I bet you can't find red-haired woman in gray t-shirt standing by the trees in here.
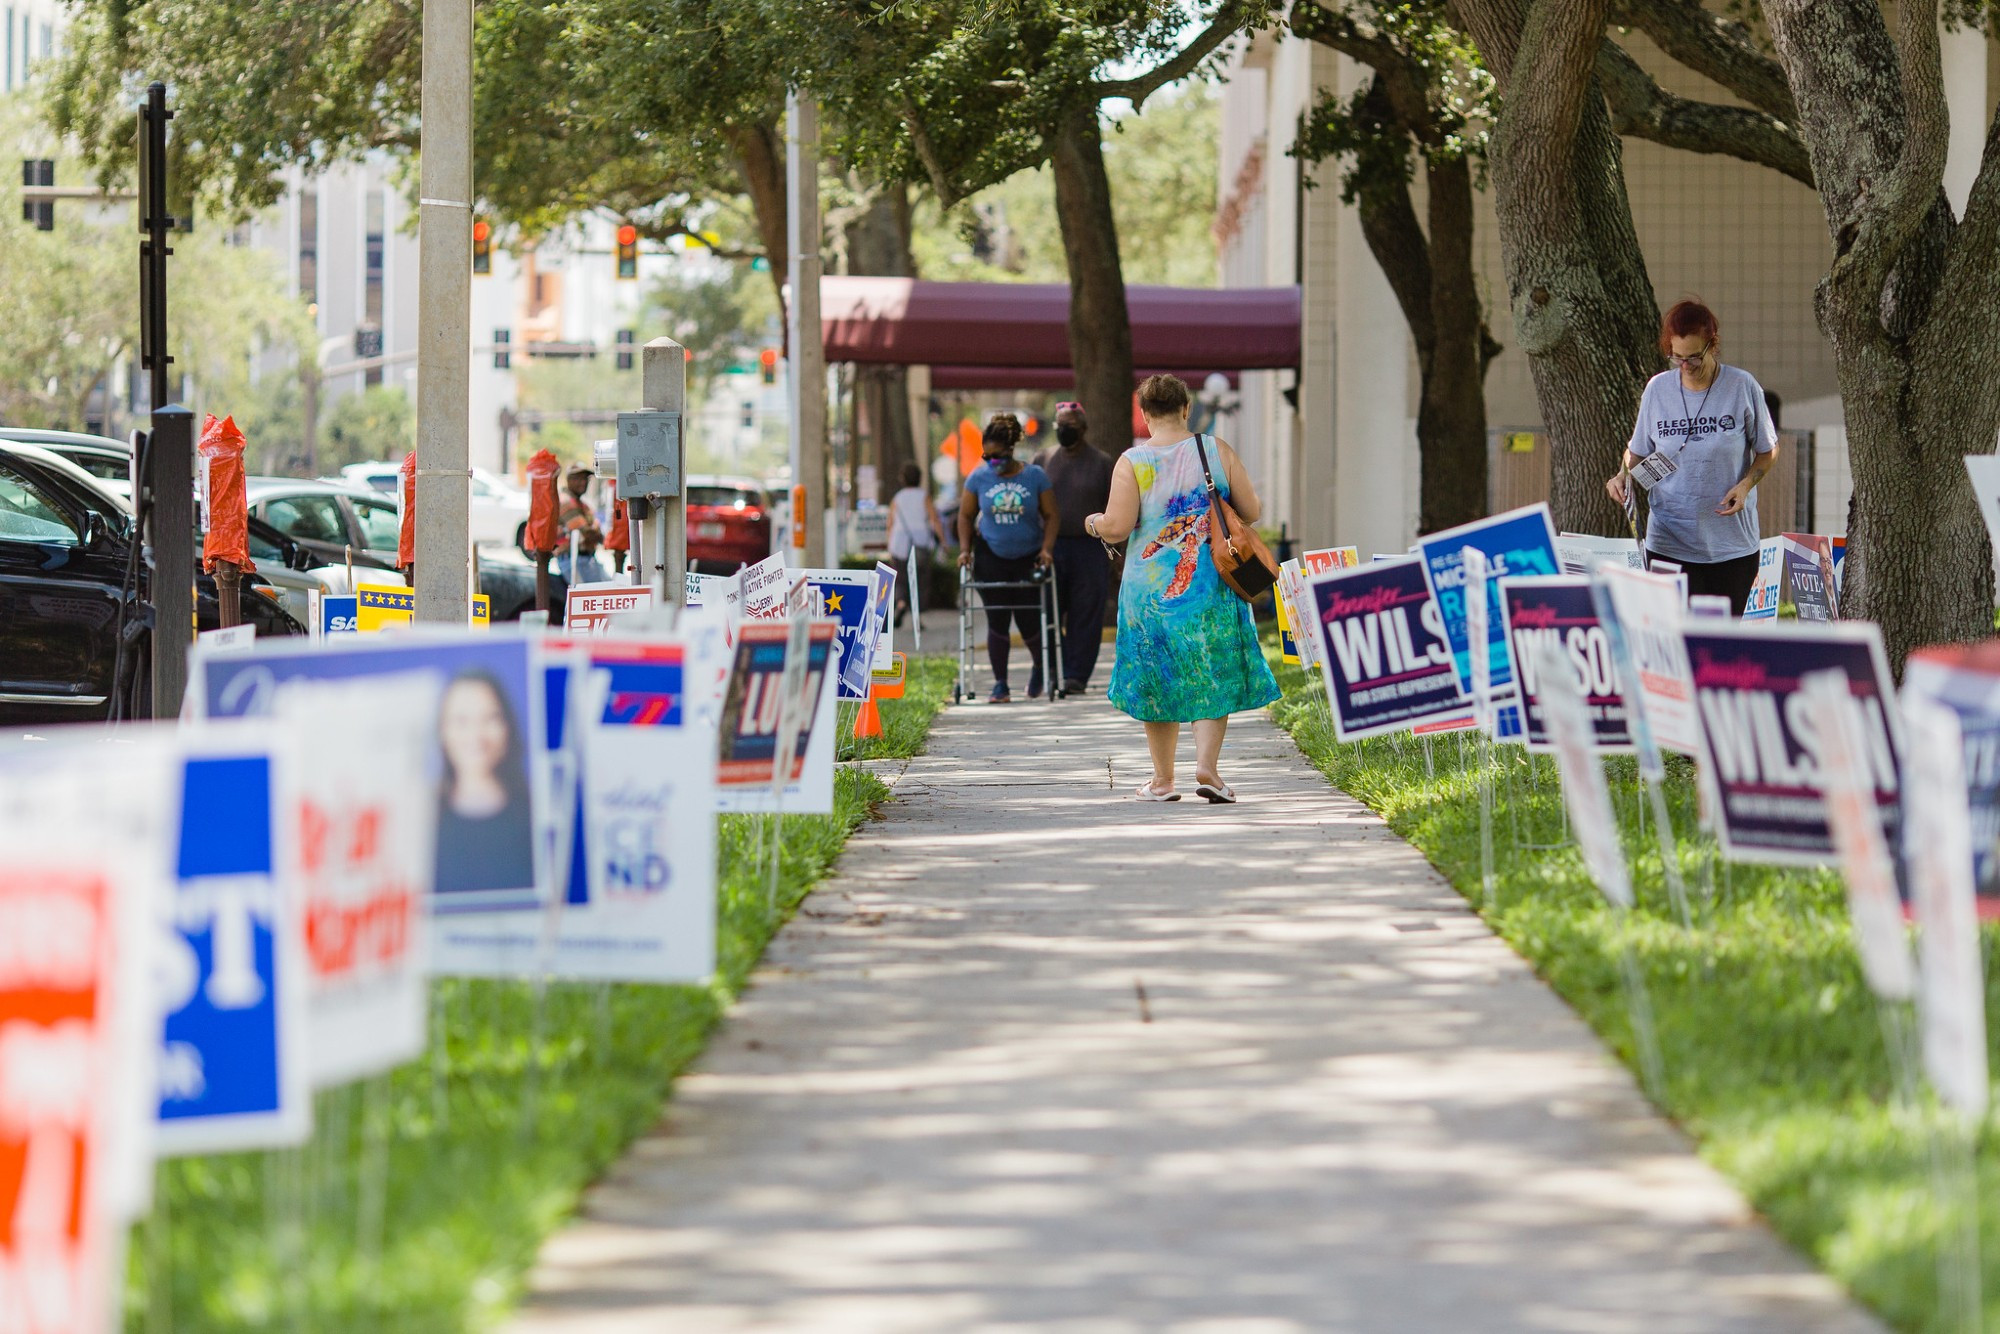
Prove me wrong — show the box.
[1604,302,1778,616]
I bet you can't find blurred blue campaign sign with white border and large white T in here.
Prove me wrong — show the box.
[156,730,312,1156]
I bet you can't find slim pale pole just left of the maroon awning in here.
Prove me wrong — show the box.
[784,90,820,568]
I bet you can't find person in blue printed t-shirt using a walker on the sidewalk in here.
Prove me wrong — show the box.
[958,412,1056,704]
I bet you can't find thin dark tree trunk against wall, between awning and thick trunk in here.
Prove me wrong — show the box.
[1416,158,1490,532]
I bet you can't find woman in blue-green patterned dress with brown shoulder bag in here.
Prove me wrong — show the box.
[1084,376,1278,802]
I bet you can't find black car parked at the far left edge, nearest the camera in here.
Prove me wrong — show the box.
[0,438,306,724]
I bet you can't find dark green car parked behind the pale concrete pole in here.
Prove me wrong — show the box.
[248,478,568,620]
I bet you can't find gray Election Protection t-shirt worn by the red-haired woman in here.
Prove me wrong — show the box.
[1632,366,1778,564]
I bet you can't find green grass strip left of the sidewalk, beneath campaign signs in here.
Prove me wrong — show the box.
[126,660,952,1334]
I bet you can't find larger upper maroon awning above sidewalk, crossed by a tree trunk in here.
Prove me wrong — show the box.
[820,278,1300,374]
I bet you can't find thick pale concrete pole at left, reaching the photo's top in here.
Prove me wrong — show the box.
[416,0,472,626]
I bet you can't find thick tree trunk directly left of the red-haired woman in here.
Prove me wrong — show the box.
[1460,0,1660,534]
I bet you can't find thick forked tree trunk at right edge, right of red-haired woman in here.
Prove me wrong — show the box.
[1764,0,2000,672]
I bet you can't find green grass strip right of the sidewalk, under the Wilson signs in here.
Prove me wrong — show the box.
[1272,660,2000,1334]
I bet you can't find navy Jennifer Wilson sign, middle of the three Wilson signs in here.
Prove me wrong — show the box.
[1500,574,1632,750]
